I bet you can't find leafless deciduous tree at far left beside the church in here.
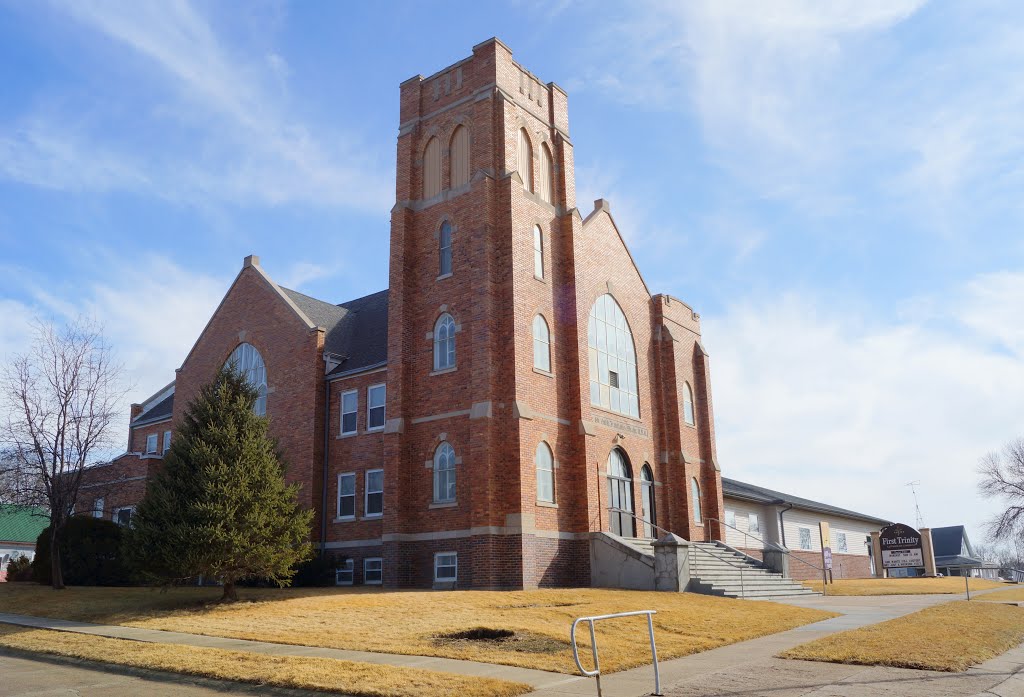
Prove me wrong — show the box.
[0,320,126,589]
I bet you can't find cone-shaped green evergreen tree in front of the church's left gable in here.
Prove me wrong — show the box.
[126,367,313,601]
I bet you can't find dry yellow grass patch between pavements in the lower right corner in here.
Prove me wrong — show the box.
[780,597,1024,671]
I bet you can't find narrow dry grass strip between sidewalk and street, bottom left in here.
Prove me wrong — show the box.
[0,624,530,697]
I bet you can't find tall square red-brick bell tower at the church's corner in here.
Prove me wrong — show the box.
[383,39,589,587]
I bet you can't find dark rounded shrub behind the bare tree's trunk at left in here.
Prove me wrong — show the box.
[32,516,129,585]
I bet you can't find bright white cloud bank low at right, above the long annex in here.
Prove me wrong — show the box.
[703,272,1024,540]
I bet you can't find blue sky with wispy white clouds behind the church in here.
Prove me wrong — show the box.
[0,0,1024,539]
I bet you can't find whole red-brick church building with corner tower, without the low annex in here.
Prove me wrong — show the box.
[79,39,724,589]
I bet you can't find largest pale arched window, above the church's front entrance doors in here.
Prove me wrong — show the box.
[587,294,640,419]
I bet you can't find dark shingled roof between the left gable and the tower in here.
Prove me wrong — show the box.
[281,288,388,375]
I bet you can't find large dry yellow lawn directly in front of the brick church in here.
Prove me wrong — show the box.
[0,583,834,673]
